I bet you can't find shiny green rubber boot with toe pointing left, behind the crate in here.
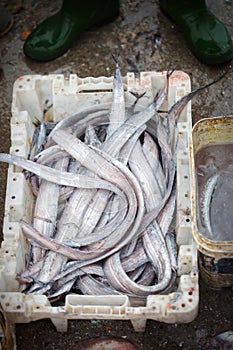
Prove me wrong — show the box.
[23,0,120,61]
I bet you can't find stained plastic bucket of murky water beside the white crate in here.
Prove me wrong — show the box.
[191,116,233,288]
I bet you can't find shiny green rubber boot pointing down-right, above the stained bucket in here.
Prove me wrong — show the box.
[160,0,233,65]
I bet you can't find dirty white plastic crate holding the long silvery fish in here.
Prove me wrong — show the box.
[0,71,199,332]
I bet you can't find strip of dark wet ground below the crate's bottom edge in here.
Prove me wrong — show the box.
[16,286,233,350]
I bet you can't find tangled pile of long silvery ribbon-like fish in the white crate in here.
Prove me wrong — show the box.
[0,61,226,301]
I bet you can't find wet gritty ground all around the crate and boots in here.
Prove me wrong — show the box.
[0,0,233,350]
